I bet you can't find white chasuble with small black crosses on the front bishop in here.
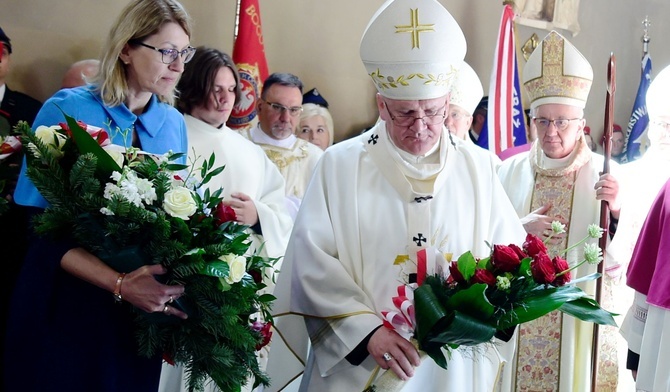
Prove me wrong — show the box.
[268,122,525,392]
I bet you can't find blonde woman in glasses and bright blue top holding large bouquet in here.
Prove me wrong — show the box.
[3,0,195,392]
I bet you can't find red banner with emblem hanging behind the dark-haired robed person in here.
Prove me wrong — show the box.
[228,0,268,128]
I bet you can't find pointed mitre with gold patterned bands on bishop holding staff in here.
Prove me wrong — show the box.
[523,31,593,109]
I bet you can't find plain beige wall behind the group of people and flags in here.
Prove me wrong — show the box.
[0,0,670,145]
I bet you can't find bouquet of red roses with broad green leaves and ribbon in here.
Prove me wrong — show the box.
[366,222,616,391]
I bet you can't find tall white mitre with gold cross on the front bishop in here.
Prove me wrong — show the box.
[360,0,466,100]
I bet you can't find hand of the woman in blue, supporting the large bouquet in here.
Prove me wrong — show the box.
[121,265,188,319]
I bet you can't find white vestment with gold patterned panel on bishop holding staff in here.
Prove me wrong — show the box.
[499,140,618,392]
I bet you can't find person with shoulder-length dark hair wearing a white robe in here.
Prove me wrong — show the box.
[159,47,293,392]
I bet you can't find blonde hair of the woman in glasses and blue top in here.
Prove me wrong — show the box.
[92,0,191,106]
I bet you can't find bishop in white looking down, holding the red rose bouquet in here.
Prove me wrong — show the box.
[268,0,525,392]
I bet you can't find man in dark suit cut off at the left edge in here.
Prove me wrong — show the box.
[0,28,42,384]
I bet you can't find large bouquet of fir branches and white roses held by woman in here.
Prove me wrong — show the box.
[19,116,276,391]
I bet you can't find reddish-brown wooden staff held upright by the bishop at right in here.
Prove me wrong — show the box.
[591,53,616,392]
